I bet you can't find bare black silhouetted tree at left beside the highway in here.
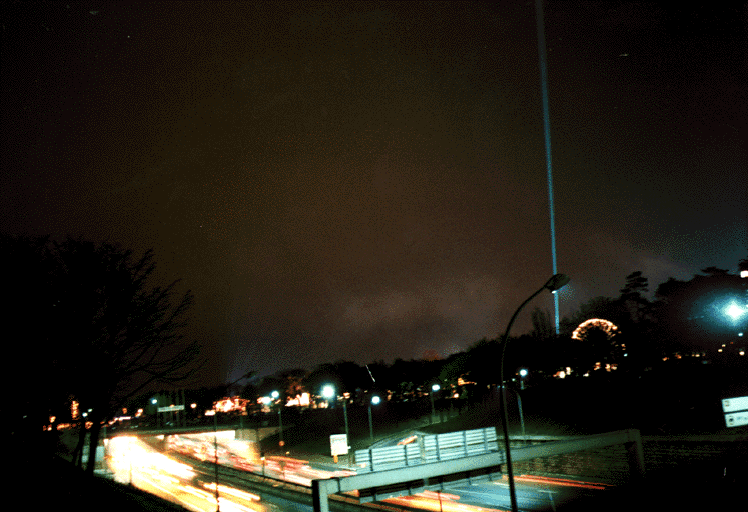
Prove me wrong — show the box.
[3,239,198,473]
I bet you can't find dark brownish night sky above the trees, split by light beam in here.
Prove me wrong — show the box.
[0,1,748,382]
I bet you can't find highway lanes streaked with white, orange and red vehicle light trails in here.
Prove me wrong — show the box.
[108,437,610,512]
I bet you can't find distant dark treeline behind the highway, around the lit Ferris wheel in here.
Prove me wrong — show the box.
[243,259,748,401]
